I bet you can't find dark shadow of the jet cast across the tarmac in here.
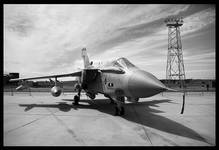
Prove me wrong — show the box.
[19,99,208,143]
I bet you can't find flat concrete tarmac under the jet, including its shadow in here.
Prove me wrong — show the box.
[3,92,216,146]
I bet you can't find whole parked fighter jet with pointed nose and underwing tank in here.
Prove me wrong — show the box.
[10,48,175,115]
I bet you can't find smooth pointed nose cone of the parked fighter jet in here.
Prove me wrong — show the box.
[128,70,166,97]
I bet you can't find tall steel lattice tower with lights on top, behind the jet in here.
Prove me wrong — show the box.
[164,16,186,89]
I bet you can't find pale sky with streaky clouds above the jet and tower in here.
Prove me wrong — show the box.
[3,4,216,79]
